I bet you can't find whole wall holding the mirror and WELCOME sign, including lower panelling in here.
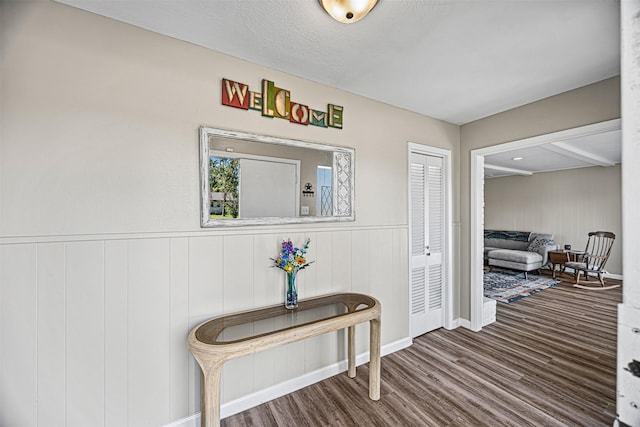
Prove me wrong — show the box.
[0,0,459,426]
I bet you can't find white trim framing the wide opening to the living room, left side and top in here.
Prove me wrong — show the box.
[469,119,621,331]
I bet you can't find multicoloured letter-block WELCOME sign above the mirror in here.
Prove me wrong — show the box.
[222,79,344,129]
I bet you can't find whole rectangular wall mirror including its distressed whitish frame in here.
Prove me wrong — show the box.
[200,127,355,227]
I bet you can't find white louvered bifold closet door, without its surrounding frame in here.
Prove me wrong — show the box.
[409,152,445,337]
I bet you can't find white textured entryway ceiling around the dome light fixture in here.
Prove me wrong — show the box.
[59,0,620,124]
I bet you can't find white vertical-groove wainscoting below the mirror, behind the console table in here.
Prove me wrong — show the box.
[0,227,409,427]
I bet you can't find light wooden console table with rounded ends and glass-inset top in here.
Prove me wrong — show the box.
[188,293,382,427]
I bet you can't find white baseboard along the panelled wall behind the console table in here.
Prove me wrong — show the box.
[163,337,413,427]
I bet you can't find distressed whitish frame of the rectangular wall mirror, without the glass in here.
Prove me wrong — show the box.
[200,126,355,228]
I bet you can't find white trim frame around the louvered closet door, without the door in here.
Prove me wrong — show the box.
[406,142,454,332]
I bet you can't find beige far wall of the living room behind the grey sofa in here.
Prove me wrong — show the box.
[484,165,623,276]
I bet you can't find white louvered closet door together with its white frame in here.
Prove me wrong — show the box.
[408,143,452,338]
